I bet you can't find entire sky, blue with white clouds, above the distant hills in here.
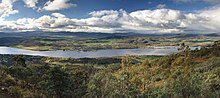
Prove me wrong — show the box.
[0,0,220,34]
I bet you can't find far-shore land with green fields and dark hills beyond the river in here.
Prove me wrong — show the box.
[0,32,220,51]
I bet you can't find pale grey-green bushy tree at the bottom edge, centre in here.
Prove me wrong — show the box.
[85,71,140,98]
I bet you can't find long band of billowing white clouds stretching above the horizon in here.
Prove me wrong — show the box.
[0,7,220,33]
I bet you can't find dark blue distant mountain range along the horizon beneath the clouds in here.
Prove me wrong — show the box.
[0,32,220,38]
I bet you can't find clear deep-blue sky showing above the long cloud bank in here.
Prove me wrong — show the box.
[7,0,215,20]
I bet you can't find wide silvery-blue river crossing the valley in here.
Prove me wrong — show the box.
[0,46,196,58]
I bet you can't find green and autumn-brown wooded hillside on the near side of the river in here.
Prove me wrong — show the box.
[0,42,220,98]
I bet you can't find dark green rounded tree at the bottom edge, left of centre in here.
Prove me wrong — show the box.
[40,66,72,98]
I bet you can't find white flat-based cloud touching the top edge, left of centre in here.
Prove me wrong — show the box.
[41,0,77,11]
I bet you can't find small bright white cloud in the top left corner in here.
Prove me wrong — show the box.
[0,0,18,18]
